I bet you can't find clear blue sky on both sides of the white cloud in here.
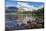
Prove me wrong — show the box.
[6,1,43,7]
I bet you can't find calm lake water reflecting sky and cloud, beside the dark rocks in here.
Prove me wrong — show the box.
[5,14,35,29]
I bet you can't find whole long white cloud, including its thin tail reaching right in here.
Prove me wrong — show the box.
[16,2,43,11]
